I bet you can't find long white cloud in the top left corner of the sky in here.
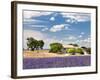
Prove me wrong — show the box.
[23,11,52,18]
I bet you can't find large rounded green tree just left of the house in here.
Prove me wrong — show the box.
[50,43,63,53]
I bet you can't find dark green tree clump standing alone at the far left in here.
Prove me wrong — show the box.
[27,37,44,51]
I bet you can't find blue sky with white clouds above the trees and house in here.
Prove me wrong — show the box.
[23,10,91,49]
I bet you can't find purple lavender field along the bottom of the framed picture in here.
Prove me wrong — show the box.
[23,56,91,69]
